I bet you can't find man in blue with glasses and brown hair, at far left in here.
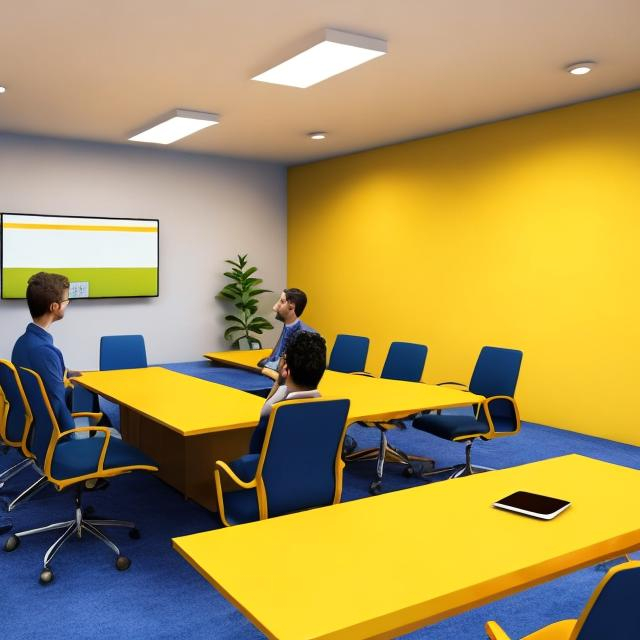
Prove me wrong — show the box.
[11,272,80,431]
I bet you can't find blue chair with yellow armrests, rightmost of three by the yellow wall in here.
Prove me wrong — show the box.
[413,347,522,478]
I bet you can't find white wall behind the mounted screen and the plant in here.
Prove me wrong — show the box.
[0,134,287,369]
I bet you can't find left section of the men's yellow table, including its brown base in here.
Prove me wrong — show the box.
[76,367,264,511]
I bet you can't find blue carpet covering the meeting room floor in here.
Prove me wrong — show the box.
[0,410,640,640]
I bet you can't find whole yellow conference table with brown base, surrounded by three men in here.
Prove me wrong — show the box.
[77,362,482,510]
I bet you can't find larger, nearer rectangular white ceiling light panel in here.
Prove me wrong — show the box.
[252,29,387,89]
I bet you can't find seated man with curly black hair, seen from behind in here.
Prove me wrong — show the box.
[229,331,327,482]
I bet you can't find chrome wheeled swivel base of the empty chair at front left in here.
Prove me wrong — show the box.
[4,488,140,585]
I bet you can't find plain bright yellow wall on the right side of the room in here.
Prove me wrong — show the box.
[288,92,640,445]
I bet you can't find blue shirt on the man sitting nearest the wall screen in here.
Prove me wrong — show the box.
[11,322,75,431]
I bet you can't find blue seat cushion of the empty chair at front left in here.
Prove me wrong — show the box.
[51,438,157,480]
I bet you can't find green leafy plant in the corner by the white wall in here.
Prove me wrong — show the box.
[218,254,273,349]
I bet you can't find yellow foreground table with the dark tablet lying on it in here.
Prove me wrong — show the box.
[173,455,640,640]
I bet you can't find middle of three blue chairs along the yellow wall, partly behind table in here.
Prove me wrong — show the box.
[345,342,434,495]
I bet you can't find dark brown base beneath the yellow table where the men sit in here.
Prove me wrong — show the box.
[120,406,253,511]
